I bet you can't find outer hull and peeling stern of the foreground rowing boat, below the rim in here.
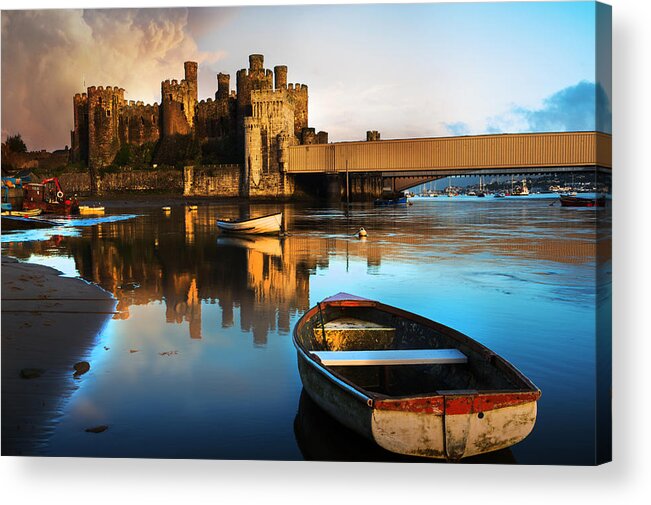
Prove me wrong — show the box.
[298,353,538,460]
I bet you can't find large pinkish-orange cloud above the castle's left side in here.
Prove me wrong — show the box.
[2,9,229,150]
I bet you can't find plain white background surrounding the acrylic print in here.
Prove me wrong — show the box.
[0,0,651,505]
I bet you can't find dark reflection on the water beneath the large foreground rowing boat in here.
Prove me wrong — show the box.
[294,390,517,464]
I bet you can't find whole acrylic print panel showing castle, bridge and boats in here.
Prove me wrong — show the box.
[2,2,612,465]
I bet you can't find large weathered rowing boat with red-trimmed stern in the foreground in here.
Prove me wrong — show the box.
[293,293,540,460]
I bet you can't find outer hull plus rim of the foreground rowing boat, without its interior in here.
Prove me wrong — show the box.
[294,292,540,460]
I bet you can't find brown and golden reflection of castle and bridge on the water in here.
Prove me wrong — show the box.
[3,201,610,345]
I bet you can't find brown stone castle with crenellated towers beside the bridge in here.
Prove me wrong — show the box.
[71,54,328,196]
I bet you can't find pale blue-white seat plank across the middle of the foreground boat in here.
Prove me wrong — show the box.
[312,349,468,366]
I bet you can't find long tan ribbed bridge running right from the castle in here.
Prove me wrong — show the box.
[285,132,612,191]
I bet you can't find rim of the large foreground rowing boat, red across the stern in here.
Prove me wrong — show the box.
[292,295,541,411]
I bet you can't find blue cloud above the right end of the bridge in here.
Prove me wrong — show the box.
[486,81,612,133]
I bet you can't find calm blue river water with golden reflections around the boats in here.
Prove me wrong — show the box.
[2,195,611,464]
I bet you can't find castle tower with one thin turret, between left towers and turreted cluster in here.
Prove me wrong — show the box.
[161,61,198,137]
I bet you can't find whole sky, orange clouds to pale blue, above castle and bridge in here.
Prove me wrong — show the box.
[2,2,611,150]
